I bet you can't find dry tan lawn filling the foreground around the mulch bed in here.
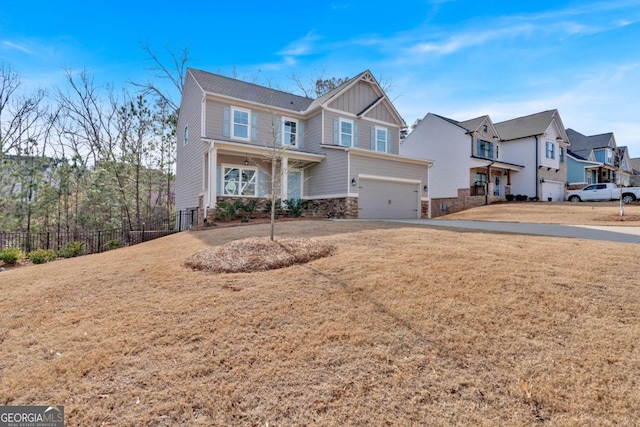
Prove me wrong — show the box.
[0,204,640,426]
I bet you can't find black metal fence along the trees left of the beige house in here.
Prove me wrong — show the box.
[0,209,198,255]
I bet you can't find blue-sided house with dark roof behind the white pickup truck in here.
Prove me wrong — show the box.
[567,129,632,188]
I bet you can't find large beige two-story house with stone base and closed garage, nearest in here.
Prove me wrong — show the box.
[176,68,432,222]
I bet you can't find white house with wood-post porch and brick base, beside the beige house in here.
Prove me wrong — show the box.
[400,113,524,216]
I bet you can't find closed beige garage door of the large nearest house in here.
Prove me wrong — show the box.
[358,179,420,219]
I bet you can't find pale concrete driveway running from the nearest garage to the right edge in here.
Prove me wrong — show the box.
[378,219,640,244]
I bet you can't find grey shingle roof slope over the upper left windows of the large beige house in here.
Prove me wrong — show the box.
[189,68,313,112]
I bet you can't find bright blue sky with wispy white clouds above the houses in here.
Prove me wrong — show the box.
[0,0,640,157]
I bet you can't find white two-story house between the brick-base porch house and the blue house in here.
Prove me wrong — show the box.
[495,109,570,201]
